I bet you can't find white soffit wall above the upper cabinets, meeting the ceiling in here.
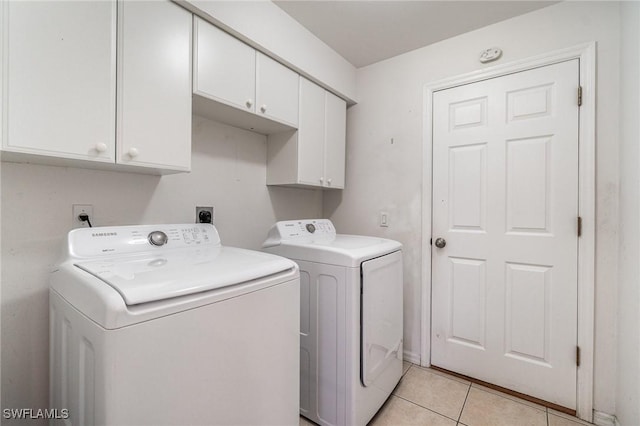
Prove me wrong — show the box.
[178,0,356,102]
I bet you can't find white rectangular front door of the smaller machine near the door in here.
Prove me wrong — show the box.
[360,251,403,386]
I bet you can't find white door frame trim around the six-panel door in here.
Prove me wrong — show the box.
[420,42,596,421]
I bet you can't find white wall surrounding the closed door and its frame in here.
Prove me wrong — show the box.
[323,2,620,413]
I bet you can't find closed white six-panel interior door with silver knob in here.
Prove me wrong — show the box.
[431,60,579,409]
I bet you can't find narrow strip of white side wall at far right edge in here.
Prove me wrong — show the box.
[616,2,640,426]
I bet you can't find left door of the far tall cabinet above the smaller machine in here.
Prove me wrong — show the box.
[298,77,325,186]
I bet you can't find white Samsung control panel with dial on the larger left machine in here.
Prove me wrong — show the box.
[68,223,220,258]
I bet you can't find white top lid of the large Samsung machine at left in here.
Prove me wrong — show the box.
[74,246,295,305]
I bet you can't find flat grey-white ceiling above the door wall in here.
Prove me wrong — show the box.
[274,0,558,68]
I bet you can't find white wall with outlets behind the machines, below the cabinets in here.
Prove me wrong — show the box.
[0,117,322,424]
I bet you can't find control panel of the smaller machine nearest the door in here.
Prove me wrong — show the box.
[262,219,336,247]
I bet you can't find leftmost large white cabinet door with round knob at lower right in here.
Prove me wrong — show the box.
[0,1,116,162]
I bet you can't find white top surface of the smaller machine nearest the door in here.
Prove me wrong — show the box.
[263,234,402,268]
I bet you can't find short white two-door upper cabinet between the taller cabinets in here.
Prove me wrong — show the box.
[193,17,299,134]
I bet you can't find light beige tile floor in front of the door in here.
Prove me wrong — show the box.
[300,362,591,426]
